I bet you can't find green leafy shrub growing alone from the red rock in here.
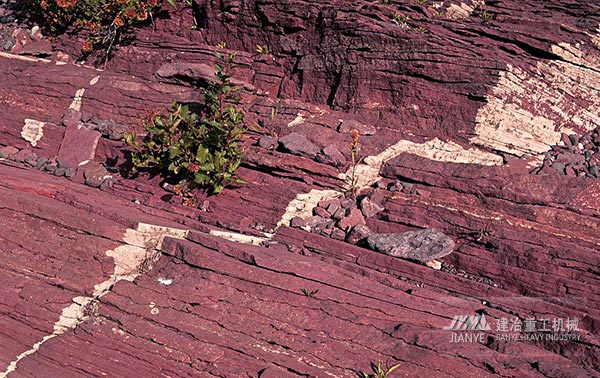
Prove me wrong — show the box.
[124,52,246,194]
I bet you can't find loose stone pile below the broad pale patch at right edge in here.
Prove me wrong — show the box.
[535,128,600,178]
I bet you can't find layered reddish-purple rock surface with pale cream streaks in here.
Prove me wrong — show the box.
[0,0,600,377]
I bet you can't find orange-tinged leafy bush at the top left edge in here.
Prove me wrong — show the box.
[27,0,177,59]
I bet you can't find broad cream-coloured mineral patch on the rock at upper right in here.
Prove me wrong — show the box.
[471,37,600,156]
